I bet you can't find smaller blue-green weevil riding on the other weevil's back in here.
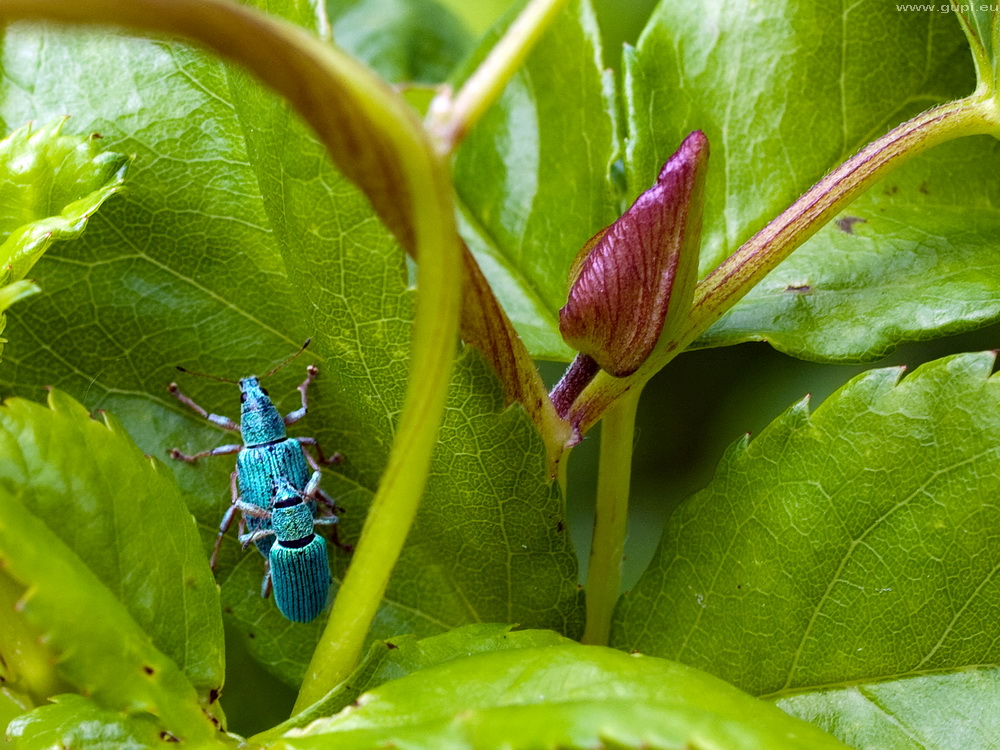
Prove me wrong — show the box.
[235,471,337,622]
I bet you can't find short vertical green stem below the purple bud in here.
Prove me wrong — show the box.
[582,388,642,646]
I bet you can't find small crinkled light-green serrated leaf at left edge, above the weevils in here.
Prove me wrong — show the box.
[0,118,128,354]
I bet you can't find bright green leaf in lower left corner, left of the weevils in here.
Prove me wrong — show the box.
[0,391,222,742]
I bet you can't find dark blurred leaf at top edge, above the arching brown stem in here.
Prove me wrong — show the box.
[326,0,472,83]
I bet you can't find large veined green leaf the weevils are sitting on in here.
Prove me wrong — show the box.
[0,0,582,683]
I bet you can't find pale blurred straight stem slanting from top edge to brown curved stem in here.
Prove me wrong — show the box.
[427,0,569,154]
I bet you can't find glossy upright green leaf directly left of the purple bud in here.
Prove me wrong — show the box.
[455,0,624,361]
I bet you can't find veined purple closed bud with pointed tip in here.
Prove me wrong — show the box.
[559,130,708,377]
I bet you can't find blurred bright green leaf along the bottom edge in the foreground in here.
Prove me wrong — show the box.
[282,643,844,750]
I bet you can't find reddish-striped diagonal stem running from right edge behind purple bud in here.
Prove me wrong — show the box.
[569,92,1000,434]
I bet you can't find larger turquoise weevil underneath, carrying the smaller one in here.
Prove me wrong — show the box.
[168,341,349,612]
